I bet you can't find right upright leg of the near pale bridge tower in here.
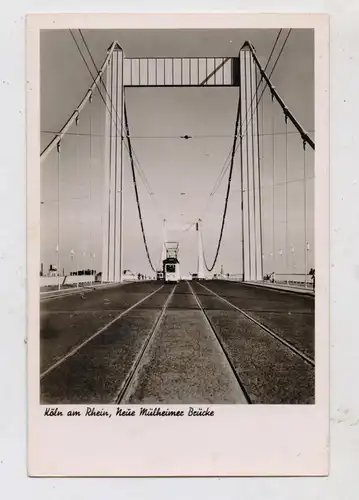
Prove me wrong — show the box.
[238,42,263,281]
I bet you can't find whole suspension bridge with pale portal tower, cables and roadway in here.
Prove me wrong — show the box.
[40,30,315,404]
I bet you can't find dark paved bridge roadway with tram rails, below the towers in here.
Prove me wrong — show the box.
[40,281,314,404]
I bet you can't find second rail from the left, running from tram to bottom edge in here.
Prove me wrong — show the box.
[113,285,177,404]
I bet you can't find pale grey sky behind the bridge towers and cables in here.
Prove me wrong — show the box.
[40,30,315,275]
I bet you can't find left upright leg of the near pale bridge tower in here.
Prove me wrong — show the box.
[102,48,124,282]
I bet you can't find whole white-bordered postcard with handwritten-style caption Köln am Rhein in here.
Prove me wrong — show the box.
[27,14,329,476]
